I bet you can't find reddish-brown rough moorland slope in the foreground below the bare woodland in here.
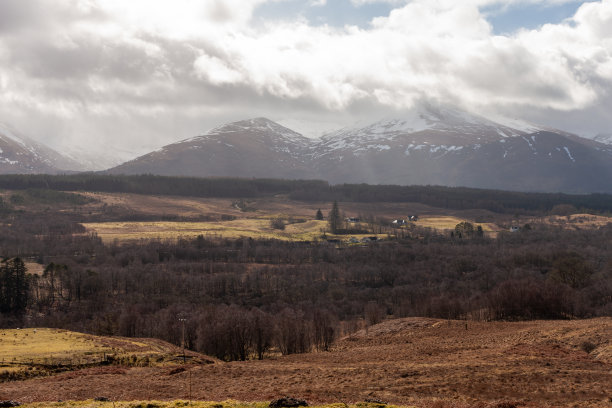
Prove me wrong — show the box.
[0,318,612,408]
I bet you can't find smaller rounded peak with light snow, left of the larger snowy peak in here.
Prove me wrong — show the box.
[109,118,315,178]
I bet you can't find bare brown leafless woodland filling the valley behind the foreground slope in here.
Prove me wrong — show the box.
[0,210,612,360]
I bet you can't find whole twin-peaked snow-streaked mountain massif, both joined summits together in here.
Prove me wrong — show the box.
[109,106,612,193]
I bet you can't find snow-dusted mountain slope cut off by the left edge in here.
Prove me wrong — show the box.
[0,123,83,174]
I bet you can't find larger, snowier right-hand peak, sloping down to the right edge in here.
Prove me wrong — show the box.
[313,106,612,192]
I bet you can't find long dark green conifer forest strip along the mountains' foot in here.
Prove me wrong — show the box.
[0,174,612,214]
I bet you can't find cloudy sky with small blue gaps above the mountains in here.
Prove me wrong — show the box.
[0,0,612,166]
